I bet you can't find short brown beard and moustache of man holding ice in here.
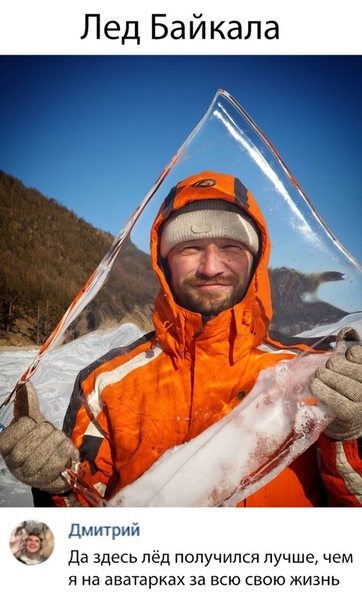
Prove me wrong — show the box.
[173,276,249,316]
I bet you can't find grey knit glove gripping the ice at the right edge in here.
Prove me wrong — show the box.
[309,328,362,441]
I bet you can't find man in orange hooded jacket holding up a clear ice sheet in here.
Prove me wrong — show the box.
[0,172,362,507]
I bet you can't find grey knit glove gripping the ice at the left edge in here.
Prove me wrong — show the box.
[0,382,79,494]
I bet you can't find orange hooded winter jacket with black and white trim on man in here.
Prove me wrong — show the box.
[58,172,358,507]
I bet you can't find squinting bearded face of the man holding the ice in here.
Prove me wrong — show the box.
[167,239,253,316]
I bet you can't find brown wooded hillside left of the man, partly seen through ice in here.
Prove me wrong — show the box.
[0,171,157,345]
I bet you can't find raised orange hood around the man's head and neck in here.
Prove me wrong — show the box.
[151,171,272,362]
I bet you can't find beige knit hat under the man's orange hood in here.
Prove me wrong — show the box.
[160,199,259,258]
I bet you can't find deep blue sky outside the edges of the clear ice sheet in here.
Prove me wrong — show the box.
[0,55,362,261]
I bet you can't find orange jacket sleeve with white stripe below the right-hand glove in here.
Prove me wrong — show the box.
[318,434,362,507]
